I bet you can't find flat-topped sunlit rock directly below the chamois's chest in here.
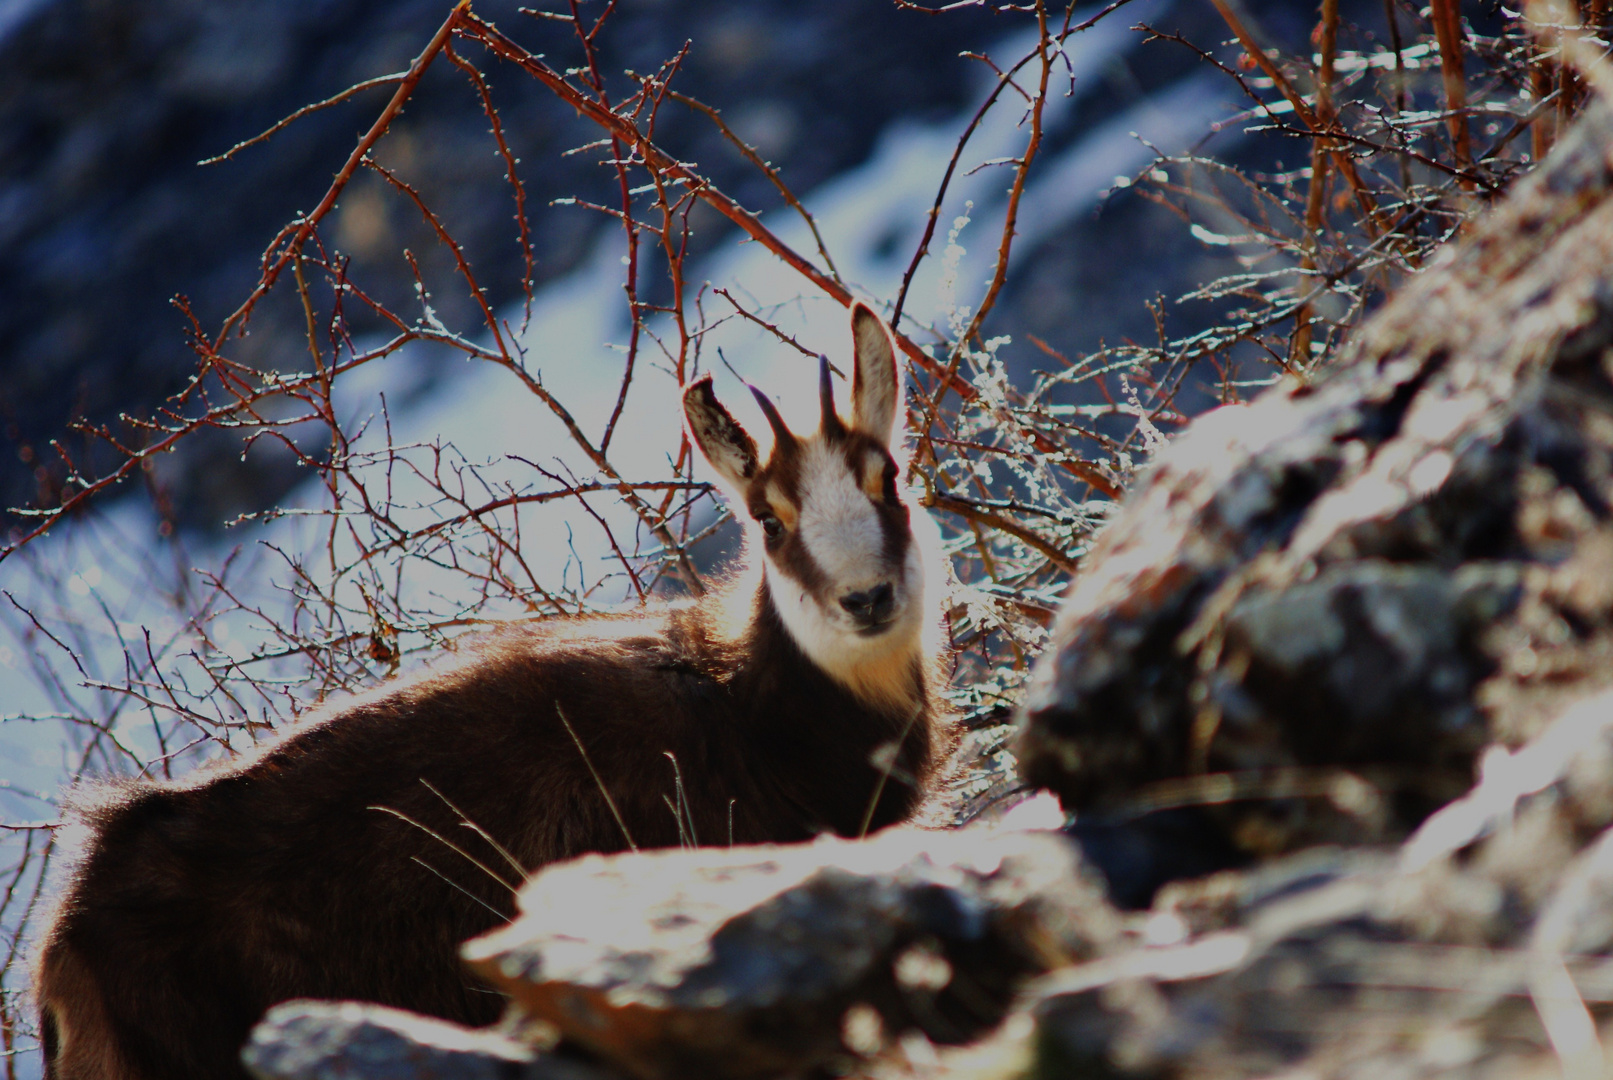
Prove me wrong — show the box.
[465,829,1116,1080]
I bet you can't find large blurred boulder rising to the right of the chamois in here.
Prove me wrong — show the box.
[1018,101,1613,858]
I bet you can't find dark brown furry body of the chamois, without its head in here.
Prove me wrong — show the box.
[35,588,942,1080]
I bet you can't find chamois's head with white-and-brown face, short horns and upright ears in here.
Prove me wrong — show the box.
[684,303,926,704]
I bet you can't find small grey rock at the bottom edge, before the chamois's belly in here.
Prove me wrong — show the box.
[242,1001,610,1080]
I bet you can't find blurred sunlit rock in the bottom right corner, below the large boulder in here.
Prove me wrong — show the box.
[1036,692,1613,1080]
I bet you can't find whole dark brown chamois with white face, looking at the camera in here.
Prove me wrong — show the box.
[34,305,948,1080]
